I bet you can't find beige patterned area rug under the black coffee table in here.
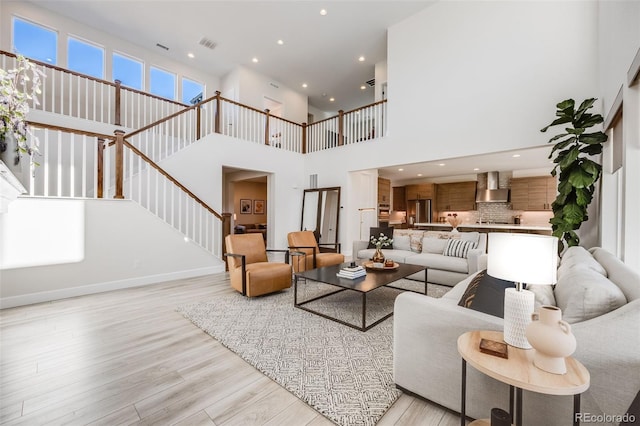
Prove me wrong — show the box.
[177,280,448,426]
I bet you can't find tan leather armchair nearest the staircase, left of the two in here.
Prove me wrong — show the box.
[225,234,292,297]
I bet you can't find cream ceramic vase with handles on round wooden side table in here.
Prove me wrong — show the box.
[526,305,576,374]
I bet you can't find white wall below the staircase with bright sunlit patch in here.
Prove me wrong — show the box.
[0,198,224,308]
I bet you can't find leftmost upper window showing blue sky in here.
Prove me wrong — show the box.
[13,16,58,65]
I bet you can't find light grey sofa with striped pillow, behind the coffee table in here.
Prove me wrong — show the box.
[353,229,487,286]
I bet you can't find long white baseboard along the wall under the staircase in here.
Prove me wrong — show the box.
[0,264,225,309]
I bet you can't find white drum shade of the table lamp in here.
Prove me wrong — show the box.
[487,232,558,284]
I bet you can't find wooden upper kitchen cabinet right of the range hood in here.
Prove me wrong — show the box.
[511,176,557,210]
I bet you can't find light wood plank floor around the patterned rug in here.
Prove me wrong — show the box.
[0,274,460,426]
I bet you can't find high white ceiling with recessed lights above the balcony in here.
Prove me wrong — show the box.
[30,0,433,111]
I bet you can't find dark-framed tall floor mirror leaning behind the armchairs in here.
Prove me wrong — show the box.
[300,186,340,248]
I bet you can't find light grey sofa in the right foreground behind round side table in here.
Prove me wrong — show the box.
[393,247,640,426]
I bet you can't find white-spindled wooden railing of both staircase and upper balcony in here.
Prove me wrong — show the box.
[0,51,386,256]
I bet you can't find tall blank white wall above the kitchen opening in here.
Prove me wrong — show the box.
[388,1,598,162]
